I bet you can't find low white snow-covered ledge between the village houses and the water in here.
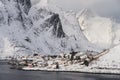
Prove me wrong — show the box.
[23,67,120,74]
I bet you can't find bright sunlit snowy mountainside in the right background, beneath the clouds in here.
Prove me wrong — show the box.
[77,9,114,48]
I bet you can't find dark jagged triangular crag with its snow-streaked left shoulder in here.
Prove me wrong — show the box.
[31,9,65,38]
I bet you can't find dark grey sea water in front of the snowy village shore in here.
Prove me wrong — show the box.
[0,64,120,80]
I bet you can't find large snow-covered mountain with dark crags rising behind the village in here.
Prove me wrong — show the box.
[0,0,101,56]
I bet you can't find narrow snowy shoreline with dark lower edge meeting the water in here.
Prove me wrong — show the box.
[22,68,120,75]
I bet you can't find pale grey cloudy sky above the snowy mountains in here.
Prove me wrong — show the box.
[31,0,120,19]
